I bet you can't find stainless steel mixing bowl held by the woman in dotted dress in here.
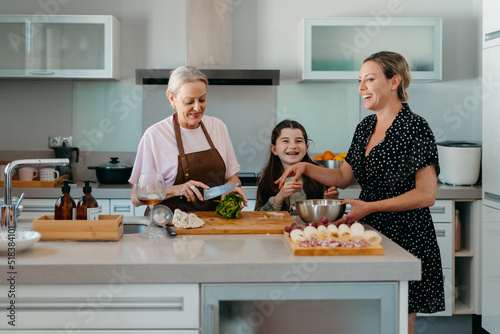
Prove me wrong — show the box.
[295,199,345,223]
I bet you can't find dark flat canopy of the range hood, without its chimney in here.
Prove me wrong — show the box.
[135,69,280,86]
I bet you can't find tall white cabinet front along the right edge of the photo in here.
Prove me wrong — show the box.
[481,0,500,334]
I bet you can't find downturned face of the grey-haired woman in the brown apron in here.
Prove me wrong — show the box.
[168,80,207,129]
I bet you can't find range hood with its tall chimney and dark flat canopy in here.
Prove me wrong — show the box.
[135,0,280,86]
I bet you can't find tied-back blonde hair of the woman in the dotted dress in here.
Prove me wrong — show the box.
[363,51,411,102]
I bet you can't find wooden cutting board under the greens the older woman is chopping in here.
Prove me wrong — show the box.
[177,211,295,235]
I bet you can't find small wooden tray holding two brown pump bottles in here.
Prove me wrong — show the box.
[33,215,123,241]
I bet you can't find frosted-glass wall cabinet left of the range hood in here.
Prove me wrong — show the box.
[0,15,120,79]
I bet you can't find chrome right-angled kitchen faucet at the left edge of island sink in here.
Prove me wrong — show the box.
[0,159,69,232]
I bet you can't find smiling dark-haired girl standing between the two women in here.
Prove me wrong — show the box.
[255,120,339,211]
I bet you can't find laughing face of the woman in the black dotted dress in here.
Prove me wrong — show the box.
[358,60,397,111]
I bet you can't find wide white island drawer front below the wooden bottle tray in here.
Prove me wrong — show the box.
[0,284,200,332]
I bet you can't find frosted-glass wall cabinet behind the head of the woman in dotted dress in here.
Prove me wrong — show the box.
[299,17,442,81]
